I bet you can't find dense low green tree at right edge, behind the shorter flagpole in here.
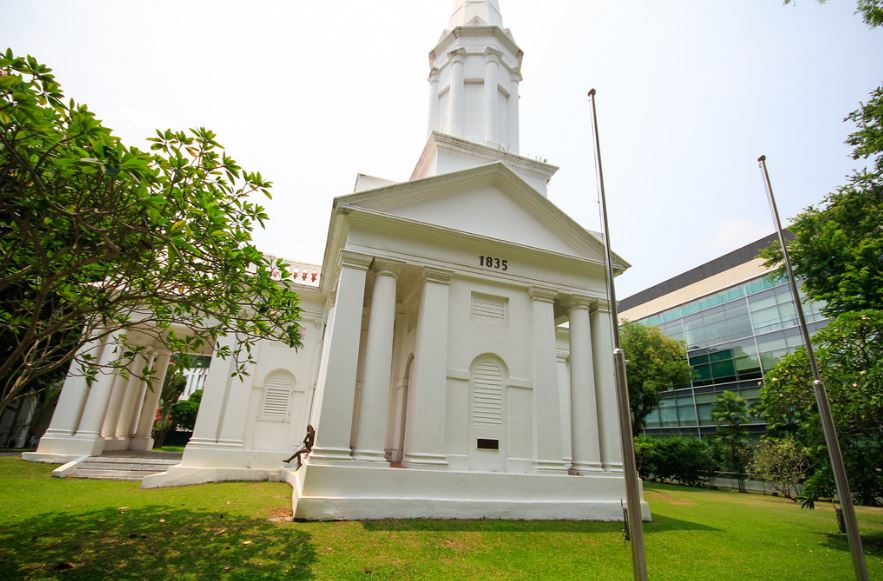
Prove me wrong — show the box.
[759,311,883,504]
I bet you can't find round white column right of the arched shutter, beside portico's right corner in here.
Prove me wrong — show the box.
[570,298,604,472]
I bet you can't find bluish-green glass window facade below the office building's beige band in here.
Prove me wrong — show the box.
[637,273,826,435]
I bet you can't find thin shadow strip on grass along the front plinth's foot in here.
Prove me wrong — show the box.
[361,516,721,533]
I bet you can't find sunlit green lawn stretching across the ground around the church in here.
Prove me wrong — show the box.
[0,458,883,580]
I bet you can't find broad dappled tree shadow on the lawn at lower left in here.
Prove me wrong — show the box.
[0,506,315,579]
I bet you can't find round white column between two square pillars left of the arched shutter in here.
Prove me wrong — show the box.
[353,259,404,462]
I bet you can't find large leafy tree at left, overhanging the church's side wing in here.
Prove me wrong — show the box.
[0,50,300,411]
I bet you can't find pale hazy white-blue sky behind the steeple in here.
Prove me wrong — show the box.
[0,0,883,298]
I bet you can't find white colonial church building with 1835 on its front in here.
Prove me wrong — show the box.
[26,0,649,520]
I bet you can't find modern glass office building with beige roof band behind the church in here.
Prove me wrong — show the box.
[620,237,826,436]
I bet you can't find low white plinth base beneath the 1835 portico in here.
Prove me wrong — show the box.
[285,465,650,521]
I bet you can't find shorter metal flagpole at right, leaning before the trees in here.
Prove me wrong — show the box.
[757,155,868,581]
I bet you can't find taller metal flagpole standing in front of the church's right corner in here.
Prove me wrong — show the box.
[589,89,647,581]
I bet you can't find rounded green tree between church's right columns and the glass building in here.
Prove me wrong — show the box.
[620,321,692,435]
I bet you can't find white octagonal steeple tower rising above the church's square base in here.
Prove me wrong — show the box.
[429,0,523,153]
